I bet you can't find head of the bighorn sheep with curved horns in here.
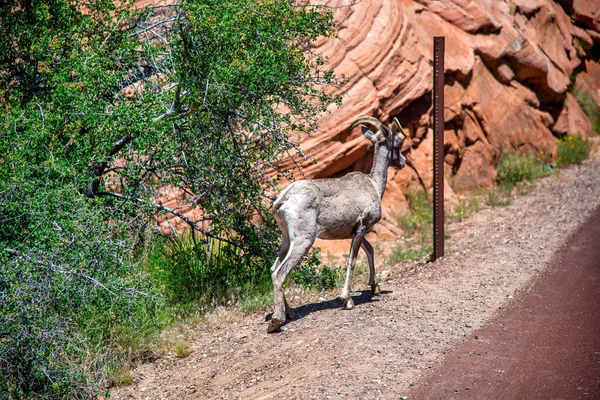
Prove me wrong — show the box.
[350,117,406,169]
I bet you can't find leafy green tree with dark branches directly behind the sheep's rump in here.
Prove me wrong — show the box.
[79,0,340,255]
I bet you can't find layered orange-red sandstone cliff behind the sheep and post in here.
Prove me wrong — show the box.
[276,0,600,248]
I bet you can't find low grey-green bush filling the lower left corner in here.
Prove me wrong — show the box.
[0,187,160,399]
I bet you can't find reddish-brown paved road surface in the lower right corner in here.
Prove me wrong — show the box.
[409,207,600,399]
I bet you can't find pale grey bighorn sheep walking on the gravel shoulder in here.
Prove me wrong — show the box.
[267,117,406,332]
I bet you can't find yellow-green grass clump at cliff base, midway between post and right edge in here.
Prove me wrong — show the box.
[497,153,552,190]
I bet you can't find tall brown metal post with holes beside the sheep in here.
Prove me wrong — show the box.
[433,36,444,261]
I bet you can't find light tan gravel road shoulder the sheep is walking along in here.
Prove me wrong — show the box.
[111,139,600,400]
